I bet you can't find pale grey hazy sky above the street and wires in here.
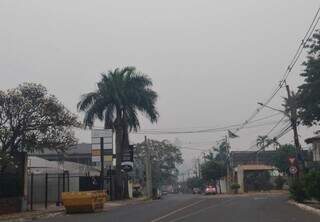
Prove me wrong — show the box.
[0,0,320,170]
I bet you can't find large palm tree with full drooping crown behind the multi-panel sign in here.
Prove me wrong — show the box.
[78,67,159,198]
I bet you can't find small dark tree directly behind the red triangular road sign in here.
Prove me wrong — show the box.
[272,144,298,173]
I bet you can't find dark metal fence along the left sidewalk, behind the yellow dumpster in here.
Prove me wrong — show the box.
[0,169,127,210]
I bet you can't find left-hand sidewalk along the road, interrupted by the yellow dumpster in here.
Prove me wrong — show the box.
[0,198,149,222]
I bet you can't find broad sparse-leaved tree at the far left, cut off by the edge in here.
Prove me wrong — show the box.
[0,83,80,171]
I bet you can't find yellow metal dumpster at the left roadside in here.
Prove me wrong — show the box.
[61,191,106,213]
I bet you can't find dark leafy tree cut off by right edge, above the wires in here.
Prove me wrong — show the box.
[297,30,320,126]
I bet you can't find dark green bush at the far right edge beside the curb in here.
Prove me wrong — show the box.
[303,171,320,201]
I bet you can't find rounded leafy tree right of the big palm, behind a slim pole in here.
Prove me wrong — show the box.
[134,140,183,188]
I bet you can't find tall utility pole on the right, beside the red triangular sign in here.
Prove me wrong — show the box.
[286,85,304,172]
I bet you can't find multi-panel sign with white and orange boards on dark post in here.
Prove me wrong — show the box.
[91,129,113,166]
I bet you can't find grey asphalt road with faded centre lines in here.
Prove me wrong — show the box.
[42,194,320,222]
